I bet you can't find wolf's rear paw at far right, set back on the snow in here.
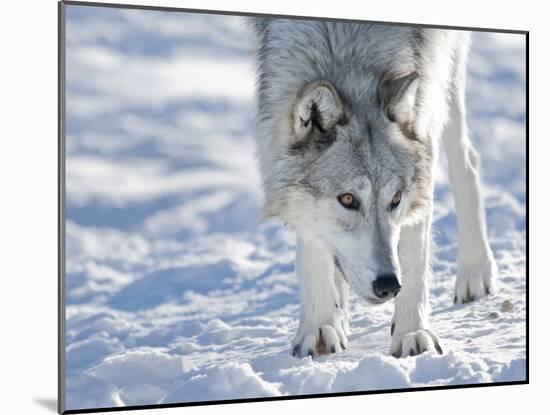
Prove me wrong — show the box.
[454,259,497,304]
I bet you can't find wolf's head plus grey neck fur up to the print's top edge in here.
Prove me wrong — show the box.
[255,19,440,302]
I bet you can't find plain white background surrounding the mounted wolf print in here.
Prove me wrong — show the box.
[0,0,550,414]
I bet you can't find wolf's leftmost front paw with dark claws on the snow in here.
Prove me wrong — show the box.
[292,322,348,357]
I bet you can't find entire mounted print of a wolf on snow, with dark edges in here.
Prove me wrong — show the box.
[59,1,528,413]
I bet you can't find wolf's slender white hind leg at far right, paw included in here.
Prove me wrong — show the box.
[443,53,497,304]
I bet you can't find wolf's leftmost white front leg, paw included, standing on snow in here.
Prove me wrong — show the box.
[292,237,347,357]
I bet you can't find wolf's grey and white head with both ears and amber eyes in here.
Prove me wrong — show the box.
[258,71,432,303]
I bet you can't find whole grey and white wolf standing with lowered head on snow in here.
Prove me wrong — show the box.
[252,17,497,357]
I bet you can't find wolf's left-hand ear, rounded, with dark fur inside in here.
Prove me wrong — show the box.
[292,80,344,140]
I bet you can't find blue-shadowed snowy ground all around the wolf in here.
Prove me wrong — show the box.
[62,6,526,409]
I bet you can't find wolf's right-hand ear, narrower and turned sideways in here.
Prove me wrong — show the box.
[379,71,419,124]
